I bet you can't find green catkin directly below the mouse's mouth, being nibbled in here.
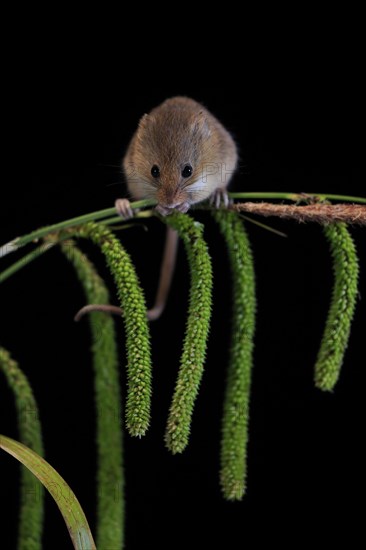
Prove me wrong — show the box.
[164,213,212,454]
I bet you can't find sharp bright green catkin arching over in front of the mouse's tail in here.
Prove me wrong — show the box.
[73,222,151,437]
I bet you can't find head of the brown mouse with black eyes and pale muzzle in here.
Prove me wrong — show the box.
[124,108,211,215]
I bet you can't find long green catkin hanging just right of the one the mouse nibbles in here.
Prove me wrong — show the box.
[213,210,256,500]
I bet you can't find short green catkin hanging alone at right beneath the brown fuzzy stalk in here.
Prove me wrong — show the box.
[314,223,358,391]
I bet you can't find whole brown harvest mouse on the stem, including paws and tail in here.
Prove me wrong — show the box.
[76,97,238,320]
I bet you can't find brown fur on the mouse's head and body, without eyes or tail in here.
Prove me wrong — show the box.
[123,97,237,211]
